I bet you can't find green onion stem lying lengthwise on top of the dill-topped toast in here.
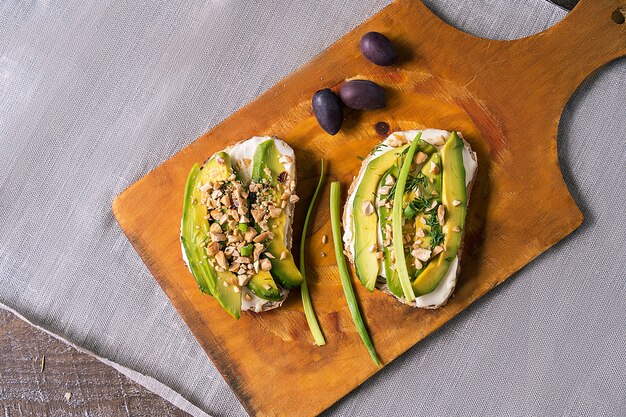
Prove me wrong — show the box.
[392,132,422,303]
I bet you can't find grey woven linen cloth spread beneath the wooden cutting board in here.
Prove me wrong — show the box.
[0,0,626,416]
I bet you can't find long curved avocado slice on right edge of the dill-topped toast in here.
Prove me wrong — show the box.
[412,132,467,296]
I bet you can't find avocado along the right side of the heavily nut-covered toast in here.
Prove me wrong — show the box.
[252,139,304,288]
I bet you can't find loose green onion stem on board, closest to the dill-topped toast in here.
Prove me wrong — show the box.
[330,182,380,365]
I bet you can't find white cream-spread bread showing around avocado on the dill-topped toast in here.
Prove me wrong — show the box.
[343,129,478,309]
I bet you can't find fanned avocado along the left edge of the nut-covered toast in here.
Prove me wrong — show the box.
[181,153,241,319]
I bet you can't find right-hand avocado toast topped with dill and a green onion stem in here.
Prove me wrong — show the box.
[343,129,477,308]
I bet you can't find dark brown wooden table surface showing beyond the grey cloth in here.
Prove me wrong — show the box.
[0,0,578,417]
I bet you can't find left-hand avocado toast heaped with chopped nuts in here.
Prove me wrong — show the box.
[181,136,303,318]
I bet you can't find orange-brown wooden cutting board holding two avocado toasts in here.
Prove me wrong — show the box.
[113,0,626,416]
